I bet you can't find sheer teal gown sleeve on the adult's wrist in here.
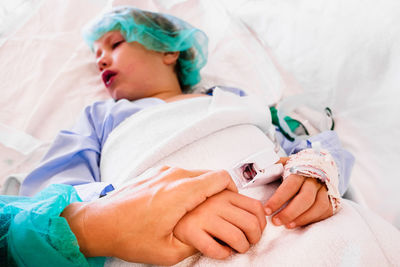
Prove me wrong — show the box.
[0,184,105,267]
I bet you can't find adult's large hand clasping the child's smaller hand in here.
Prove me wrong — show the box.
[62,167,237,265]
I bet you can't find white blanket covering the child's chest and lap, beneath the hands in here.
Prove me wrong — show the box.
[100,90,400,266]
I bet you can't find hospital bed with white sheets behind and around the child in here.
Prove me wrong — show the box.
[0,0,400,266]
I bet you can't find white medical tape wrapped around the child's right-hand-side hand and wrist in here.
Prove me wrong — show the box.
[283,148,341,214]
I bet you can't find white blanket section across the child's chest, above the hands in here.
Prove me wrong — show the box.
[100,88,279,194]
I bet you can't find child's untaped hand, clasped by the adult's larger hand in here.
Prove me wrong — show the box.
[174,190,267,259]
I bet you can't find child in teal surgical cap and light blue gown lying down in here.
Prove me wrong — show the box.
[21,7,353,263]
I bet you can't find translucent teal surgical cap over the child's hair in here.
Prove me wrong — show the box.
[83,6,208,91]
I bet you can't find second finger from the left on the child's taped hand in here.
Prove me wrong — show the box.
[272,178,322,225]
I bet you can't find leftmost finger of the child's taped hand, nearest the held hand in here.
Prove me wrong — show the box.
[264,174,305,215]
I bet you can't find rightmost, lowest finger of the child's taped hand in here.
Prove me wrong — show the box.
[288,186,333,228]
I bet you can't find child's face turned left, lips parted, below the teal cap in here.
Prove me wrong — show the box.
[94,31,178,100]
